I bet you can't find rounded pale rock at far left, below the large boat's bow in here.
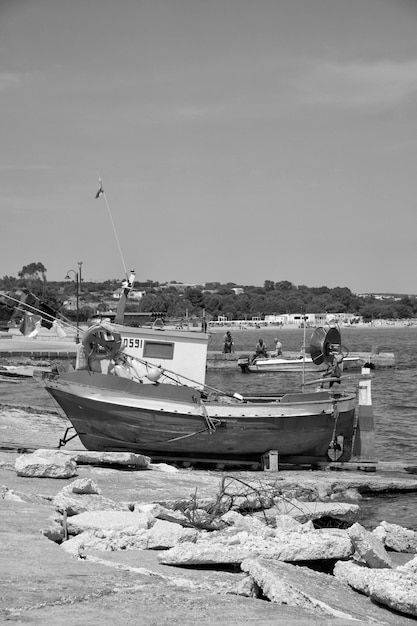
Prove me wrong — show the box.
[15,450,77,478]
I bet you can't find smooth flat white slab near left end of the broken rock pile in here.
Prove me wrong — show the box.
[67,510,153,535]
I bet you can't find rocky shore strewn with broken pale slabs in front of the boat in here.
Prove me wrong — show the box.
[0,406,417,626]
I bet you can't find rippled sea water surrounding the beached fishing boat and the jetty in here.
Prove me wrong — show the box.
[0,326,417,530]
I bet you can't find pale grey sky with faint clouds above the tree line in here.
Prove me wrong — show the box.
[0,0,417,294]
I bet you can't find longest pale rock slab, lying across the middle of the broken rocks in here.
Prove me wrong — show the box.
[158,531,352,565]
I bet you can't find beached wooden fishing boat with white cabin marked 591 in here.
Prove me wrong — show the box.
[44,282,366,465]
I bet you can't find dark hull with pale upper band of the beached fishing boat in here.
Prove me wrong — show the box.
[46,372,356,463]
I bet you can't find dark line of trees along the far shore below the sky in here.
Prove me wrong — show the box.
[0,263,417,321]
